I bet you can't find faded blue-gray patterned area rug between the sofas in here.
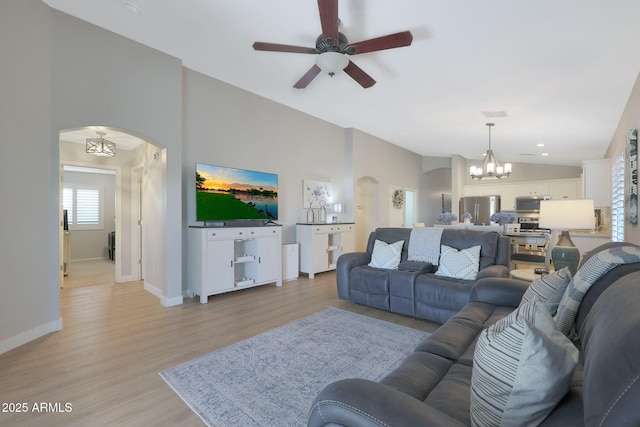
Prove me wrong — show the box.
[160,307,429,426]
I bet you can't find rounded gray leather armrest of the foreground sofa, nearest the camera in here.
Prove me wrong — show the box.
[308,379,465,427]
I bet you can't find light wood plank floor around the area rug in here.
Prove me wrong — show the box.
[0,272,437,426]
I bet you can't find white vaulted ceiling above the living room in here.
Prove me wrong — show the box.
[44,0,640,165]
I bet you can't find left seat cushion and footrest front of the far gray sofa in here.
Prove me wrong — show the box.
[349,266,391,310]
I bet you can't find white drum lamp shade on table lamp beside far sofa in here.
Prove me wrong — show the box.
[539,200,595,230]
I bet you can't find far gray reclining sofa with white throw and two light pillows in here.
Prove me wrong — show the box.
[336,228,510,324]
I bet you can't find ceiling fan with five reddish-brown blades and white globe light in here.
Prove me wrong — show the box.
[253,0,413,89]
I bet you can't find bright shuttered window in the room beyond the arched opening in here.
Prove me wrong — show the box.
[62,185,104,230]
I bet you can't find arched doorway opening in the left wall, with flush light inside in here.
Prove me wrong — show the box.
[59,126,151,287]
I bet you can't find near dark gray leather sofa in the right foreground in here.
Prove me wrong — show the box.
[308,244,640,427]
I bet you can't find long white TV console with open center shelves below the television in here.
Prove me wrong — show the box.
[187,226,282,304]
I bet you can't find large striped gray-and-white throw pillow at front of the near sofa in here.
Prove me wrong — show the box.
[470,298,578,427]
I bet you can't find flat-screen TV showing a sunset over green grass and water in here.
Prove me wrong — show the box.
[196,163,278,222]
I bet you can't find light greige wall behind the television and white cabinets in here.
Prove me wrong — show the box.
[183,69,352,243]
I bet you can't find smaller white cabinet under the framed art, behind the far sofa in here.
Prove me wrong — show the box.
[296,223,355,279]
